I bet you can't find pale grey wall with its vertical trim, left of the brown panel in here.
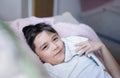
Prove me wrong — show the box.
[0,0,32,21]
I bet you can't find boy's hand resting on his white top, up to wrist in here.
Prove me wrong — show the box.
[75,41,104,55]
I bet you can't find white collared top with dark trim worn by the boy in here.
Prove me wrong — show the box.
[44,36,112,78]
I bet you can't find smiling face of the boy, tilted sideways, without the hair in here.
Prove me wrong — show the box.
[34,31,64,65]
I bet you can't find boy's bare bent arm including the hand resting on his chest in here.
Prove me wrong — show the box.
[76,41,120,78]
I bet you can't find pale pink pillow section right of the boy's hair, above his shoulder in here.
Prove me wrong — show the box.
[52,22,99,40]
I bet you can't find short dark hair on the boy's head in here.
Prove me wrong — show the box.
[22,23,57,52]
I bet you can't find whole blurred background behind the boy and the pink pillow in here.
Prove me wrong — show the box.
[0,0,120,78]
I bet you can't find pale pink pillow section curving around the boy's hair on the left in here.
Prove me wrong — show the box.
[9,16,54,41]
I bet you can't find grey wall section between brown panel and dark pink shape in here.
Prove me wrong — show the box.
[54,0,81,21]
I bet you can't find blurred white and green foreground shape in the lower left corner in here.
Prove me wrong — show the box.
[0,20,50,78]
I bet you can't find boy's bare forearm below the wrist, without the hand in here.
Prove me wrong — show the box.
[100,45,120,78]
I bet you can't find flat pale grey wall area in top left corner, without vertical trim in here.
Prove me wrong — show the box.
[0,0,21,21]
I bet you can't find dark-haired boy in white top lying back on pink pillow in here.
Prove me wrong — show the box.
[23,23,120,78]
